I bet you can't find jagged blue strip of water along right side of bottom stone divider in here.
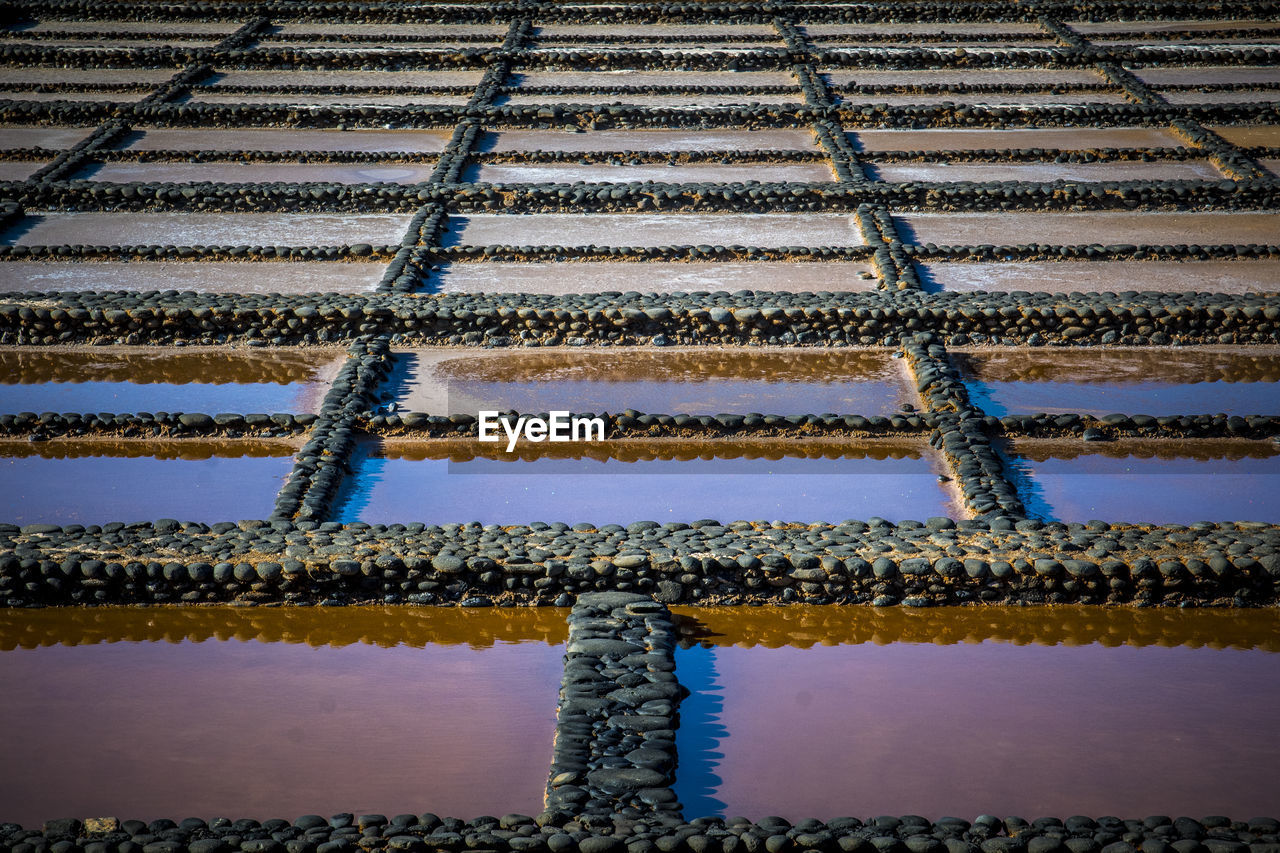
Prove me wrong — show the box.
[675,646,728,817]
